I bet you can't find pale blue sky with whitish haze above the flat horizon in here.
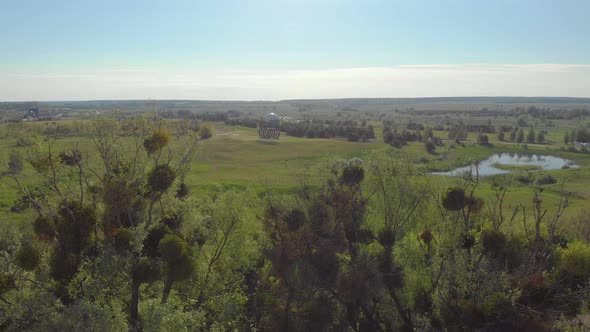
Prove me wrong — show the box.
[0,0,590,101]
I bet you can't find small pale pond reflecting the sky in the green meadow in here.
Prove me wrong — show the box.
[431,153,577,176]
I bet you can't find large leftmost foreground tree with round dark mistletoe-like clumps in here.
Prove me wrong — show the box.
[4,117,200,325]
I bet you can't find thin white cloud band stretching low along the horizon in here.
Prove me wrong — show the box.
[0,64,590,101]
